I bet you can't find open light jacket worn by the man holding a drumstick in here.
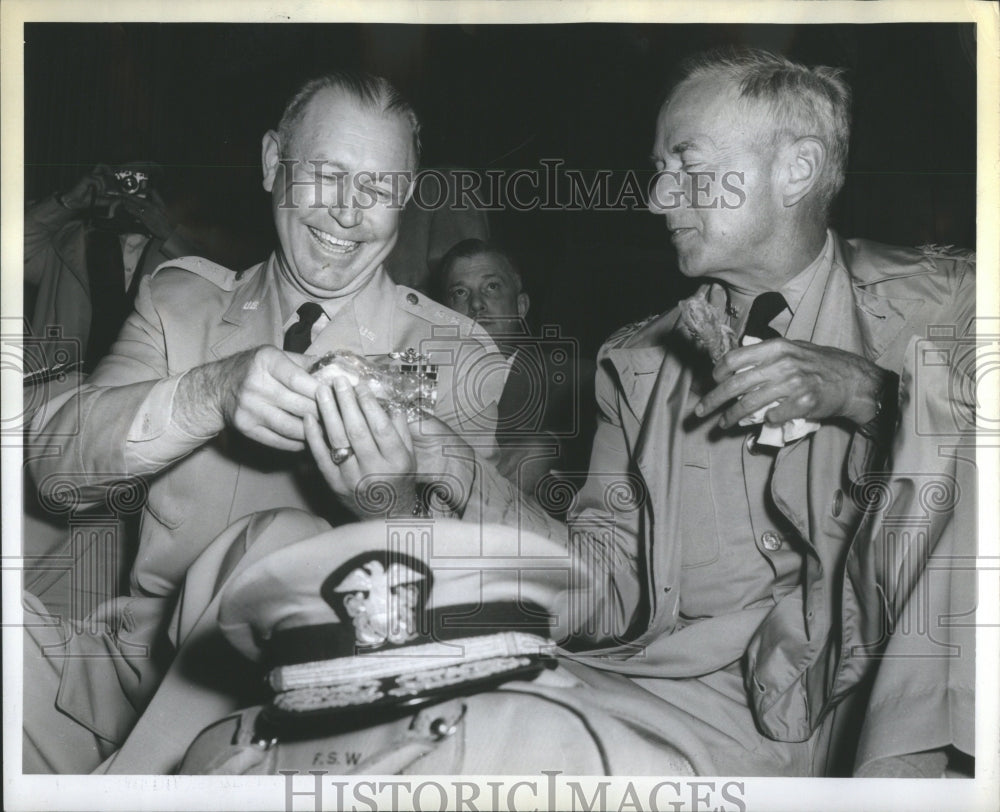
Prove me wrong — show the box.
[571,235,975,741]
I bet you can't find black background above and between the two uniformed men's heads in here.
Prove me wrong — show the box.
[25,23,976,353]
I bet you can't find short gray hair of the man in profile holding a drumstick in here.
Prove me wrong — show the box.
[675,48,851,214]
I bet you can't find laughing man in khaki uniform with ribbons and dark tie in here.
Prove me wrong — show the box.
[25,75,516,771]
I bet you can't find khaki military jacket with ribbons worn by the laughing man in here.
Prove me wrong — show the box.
[31,256,504,595]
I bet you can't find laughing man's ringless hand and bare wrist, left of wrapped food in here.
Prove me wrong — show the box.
[174,345,320,451]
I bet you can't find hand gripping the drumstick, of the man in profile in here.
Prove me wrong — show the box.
[695,338,890,428]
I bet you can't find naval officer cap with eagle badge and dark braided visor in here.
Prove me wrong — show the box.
[219,519,580,732]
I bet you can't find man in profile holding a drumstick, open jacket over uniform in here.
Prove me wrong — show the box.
[552,51,975,775]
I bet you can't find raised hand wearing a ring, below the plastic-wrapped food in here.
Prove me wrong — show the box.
[304,378,416,518]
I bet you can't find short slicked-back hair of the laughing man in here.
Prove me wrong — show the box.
[278,71,421,165]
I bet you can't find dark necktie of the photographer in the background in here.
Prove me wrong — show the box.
[84,229,131,372]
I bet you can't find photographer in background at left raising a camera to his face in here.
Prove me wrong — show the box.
[23,163,213,616]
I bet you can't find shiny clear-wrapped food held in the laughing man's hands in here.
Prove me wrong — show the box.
[309,349,437,423]
